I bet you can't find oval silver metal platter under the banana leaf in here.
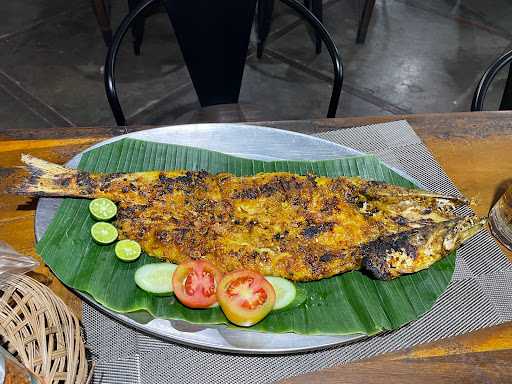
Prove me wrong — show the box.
[35,124,417,354]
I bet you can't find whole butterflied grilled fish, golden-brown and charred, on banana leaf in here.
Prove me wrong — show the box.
[14,155,485,281]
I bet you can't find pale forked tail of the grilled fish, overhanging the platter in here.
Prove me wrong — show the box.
[9,154,95,197]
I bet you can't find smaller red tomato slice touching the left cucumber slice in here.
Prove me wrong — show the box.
[172,260,222,308]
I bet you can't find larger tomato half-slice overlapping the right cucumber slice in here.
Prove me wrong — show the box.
[217,270,276,327]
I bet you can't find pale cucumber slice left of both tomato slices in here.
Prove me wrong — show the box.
[135,263,178,296]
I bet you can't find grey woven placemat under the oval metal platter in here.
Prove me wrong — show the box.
[83,121,512,384]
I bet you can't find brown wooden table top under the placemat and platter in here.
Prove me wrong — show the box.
[0,112,512,384]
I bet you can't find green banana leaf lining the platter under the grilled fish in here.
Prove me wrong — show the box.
[37,139,455,335]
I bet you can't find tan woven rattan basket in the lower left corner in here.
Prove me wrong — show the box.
[0,275,87,384]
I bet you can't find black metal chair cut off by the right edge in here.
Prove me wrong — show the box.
[471,51,512,112]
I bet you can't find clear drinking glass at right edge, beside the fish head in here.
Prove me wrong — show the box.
[489,186,512,251]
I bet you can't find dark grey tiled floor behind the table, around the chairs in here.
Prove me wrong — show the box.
[0,0,512,129]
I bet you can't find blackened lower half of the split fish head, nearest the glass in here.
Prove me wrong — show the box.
[359,216,486,280]
